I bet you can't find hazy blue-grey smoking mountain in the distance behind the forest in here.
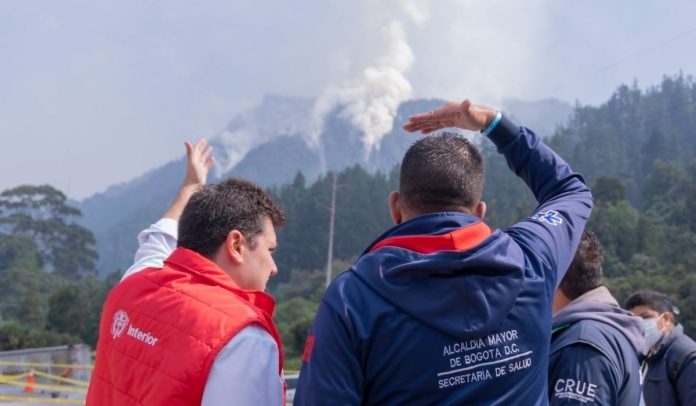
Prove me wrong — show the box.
[79,95,572,275]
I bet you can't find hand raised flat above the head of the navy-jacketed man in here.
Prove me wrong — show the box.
[404,99,497,134]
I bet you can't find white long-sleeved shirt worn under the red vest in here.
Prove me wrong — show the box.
[121,218,283,406]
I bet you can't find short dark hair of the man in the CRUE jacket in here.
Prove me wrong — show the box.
[558,230,604,300]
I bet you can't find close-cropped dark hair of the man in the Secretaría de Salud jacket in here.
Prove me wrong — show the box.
[399,133,485,214]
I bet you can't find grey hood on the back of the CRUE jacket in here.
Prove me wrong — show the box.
[553,286,647,355]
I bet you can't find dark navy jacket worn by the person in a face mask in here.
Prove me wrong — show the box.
[643,325,696,406]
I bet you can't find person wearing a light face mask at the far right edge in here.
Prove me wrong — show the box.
[625,290,696,406]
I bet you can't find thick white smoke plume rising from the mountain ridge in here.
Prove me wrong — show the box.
[309,0,429,155]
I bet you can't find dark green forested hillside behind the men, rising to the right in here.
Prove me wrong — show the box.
[271,76,696,364]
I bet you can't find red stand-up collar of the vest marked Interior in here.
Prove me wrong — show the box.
[164,247,275,315]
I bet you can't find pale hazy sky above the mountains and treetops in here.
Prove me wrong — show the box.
[0,0,696,199]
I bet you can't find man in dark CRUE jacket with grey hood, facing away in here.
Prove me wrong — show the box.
[549,231,645,406]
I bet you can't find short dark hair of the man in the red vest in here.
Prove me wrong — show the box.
[178,178,285,257]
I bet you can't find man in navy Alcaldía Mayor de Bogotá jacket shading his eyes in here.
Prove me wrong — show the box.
[294,100,592,405]
